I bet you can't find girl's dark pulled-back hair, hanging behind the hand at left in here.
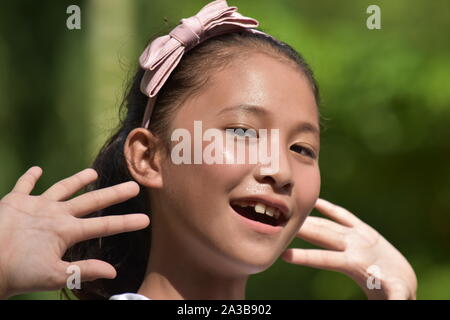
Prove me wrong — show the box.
[63,31,319,299]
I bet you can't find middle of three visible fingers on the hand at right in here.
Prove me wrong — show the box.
[297,216,347,251]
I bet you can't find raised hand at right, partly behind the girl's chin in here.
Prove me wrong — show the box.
[282,199,417,300]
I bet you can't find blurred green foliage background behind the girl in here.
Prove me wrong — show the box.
[0,0,450,299]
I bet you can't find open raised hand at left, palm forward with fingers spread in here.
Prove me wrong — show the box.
[0,167,149,298]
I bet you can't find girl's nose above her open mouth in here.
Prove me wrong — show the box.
[255,146,294,194]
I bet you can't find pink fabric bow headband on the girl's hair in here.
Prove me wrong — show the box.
[139,0,258,128]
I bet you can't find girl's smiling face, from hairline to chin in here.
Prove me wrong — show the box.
[152,53,320,275]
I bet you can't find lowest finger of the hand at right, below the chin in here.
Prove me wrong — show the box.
[281,249,347,272]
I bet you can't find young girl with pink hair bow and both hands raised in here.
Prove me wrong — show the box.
[0,0,417,299]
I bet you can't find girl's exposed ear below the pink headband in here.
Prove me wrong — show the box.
[124,128,163,188]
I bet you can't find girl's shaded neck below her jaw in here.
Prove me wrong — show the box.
[138,225,248,300]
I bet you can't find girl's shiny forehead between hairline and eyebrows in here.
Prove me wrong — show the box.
[174,54,318,124]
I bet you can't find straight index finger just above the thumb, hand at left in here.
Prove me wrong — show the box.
[74,213,150,242]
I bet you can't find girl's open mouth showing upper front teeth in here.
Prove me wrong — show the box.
[230,201,286,226]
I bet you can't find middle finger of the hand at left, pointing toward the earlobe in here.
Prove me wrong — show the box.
[65,181,139,217]
